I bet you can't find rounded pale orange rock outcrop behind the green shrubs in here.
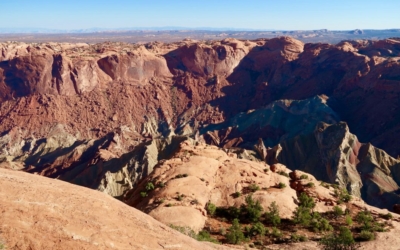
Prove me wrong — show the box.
[124,141,356,232]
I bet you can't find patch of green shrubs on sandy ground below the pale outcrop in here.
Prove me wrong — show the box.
[192,168,390,246]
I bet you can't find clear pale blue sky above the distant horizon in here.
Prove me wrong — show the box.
[0,0,400,30]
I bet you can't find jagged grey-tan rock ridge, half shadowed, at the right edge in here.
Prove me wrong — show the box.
[270,122,400,209]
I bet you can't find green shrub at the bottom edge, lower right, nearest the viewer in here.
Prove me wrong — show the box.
[319,227,360,250]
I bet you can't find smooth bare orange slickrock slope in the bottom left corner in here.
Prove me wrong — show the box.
[0,169,228,250]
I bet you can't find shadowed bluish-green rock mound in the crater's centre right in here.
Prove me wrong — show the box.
[200,96,340,149]
